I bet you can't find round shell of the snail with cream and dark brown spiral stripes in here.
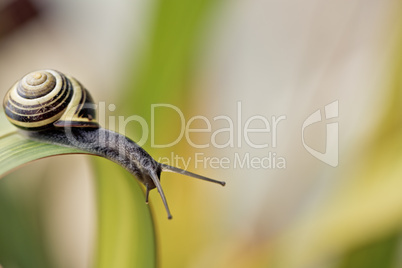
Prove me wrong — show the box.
[3,70,98,130]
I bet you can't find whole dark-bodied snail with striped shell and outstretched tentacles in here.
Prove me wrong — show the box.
[3,70,225,219]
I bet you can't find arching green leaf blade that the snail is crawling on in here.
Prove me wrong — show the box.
[0,112,156,267]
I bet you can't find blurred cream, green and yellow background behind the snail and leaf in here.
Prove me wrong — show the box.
[0,0,402,268]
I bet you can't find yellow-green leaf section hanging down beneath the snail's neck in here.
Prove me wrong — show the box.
[94,158,156,268]
